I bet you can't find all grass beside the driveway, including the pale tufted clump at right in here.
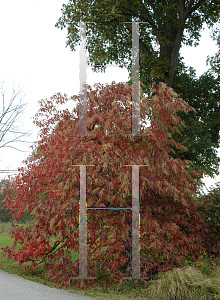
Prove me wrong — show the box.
[0,223,220,300]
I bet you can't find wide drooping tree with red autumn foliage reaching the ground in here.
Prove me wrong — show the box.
[1,82,218,286]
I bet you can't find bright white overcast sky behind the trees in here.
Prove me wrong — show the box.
[0,0,220,197]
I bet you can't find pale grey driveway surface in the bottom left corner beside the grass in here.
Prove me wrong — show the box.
[0,270,96,300]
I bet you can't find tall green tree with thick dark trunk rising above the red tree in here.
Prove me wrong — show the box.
[56,0,220,87]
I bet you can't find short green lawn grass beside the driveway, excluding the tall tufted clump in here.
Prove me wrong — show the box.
[0,223,152,300]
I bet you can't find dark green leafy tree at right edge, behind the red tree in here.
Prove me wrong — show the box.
[171,58,220,177]
